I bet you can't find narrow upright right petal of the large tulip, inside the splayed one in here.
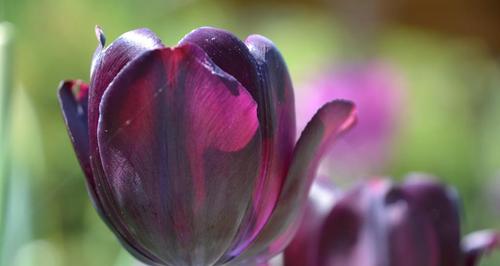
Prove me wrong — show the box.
[219,35,295,260]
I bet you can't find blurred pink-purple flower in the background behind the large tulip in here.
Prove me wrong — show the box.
[297,62,404,180]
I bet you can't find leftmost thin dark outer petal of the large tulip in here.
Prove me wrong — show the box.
[58,80,160,265]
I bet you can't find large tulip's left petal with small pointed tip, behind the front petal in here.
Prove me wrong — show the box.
[87,27,163,261]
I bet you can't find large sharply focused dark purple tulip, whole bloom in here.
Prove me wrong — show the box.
[59,28,355,265]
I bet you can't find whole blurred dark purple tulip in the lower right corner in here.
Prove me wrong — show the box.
[284,175,500,266]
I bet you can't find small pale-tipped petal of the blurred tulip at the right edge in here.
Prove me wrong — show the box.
[462,230,500,266]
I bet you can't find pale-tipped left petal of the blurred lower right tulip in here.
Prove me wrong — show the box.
[283,180,338,266]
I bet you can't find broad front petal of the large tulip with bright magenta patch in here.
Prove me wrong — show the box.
[98,45,261,265]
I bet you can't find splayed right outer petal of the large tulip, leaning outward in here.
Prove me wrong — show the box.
[232,101,356,262]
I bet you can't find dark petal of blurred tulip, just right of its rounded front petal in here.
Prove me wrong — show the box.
[402,174,462,266]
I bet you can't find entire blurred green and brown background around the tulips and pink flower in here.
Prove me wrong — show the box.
[0,0,500,266]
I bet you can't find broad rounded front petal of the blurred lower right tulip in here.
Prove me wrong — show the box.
[316,179,439,266]
